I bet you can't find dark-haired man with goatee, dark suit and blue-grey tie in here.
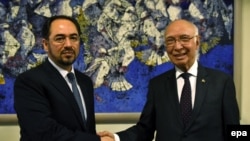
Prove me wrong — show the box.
[14,15,111,141]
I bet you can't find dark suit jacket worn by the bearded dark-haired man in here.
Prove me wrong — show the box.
[14,60,100,141]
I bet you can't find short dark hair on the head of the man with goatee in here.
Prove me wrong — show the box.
[42,15,81,39]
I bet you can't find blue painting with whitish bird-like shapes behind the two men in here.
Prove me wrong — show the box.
[0,0,234,114]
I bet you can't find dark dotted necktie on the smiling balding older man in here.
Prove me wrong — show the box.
[180,73,192,127]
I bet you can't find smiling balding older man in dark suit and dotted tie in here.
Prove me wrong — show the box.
[98,20,239,141]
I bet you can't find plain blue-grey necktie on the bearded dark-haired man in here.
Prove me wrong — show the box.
[67,72,85,122]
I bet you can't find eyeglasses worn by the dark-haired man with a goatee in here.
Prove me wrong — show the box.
[53,35,80,44]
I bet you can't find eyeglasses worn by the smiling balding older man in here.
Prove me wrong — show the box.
[165,35,197,47]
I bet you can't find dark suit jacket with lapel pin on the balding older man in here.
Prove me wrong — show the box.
[118,64,239,141]
